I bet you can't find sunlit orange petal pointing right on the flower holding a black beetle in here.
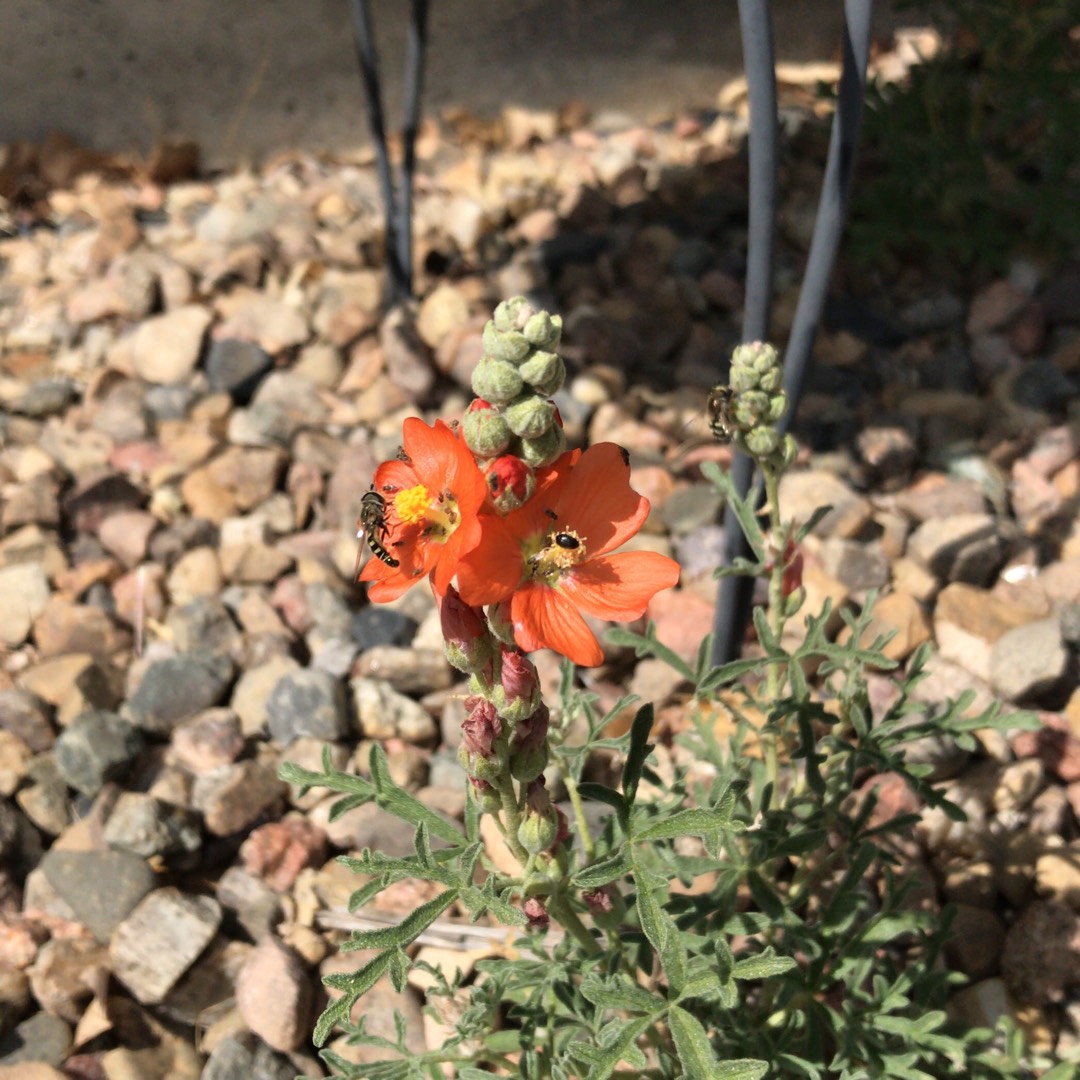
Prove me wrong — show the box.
[559,551,679,622]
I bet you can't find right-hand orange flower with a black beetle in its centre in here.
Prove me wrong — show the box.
[458,443,679,666]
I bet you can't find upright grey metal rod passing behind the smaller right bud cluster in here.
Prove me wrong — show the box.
[713,0,780,664]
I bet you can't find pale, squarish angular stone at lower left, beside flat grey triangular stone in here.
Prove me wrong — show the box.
[109,886,221,1004]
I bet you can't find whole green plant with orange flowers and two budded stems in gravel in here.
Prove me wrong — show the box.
[282,308,1045,1080]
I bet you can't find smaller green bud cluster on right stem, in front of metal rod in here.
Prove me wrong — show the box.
[727,341,797,468]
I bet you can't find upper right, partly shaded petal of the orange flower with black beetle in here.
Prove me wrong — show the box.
[554,443,649,555]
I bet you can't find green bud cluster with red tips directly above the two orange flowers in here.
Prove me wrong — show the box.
[462,296,566,513]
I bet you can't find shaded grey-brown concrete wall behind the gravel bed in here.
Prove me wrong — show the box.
[0,0,911,164]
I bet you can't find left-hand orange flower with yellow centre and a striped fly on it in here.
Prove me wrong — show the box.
[357,417,487,603]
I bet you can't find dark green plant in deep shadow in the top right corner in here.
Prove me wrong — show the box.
[850,0,1080,270]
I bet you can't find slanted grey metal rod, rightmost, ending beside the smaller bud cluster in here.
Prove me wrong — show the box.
[782,0,874,431]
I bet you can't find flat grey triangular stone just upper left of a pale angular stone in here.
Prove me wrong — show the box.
[41,849,156,942]
